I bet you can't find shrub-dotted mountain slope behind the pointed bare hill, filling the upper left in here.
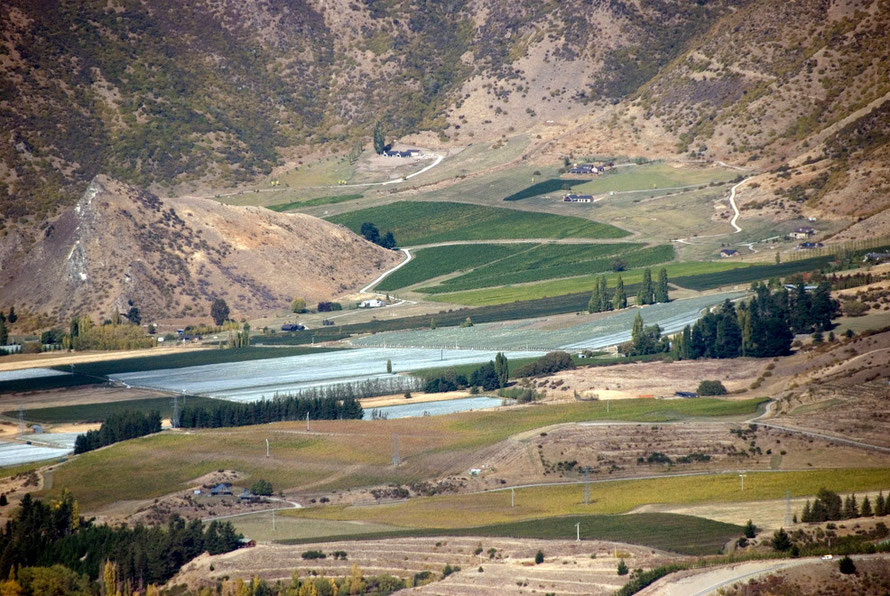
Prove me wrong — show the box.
[0,0,746,220]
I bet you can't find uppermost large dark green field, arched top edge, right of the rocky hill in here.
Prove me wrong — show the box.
[330,201,628,246]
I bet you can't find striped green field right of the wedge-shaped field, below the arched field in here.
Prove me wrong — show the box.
[420,243,674,294]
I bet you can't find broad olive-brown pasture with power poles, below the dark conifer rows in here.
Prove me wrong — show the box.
[43,399,763,511]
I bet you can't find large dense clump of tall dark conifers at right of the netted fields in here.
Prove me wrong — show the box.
[672,282,839,360]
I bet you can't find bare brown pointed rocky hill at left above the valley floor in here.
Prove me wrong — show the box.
[0,176,400,319]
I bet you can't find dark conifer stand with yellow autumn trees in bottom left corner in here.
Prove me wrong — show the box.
[0,491,241,594]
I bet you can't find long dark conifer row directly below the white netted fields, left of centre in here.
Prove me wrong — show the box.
[179,396,364,428]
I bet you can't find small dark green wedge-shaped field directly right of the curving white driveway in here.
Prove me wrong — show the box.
[376,244,535,291]
